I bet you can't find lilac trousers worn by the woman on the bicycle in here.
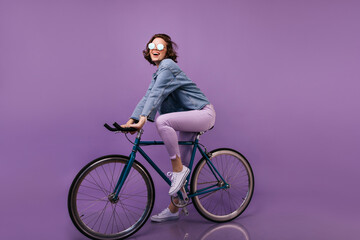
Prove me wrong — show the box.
[155,104,216,165]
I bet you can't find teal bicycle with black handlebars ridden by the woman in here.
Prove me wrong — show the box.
[68,122,254,239]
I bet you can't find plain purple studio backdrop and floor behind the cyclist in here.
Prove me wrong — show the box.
[0,0,360,240]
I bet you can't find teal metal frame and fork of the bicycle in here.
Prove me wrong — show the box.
[112,130,229,200]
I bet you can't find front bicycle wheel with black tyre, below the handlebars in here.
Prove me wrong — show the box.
[68,155,155,239]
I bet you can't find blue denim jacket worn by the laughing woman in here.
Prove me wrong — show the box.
[131,58,210,121]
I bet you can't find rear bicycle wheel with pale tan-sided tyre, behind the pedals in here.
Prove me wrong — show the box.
[190,148,254,222]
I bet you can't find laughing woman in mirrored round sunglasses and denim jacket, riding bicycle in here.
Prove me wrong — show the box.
[122,34,215,222]
